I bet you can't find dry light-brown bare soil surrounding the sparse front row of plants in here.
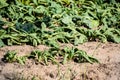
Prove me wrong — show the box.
[0,42,120,80]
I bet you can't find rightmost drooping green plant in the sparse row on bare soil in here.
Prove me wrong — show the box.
[62,47,99,63]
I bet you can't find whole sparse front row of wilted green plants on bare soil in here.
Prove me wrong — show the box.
[4,47,99,65]
